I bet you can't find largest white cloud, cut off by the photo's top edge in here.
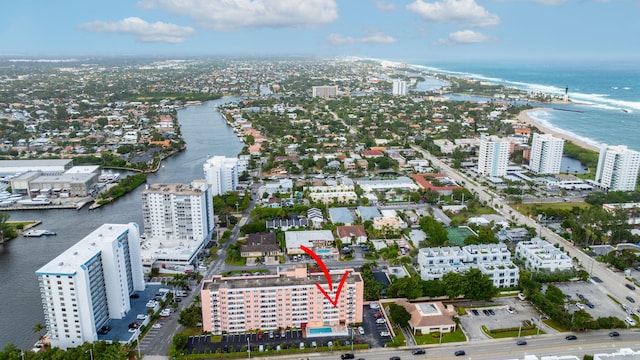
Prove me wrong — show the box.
[138,0,338,31]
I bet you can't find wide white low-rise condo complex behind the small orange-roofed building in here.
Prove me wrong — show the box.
[418,244,520,288]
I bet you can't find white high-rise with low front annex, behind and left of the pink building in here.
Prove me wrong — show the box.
[142,179,215,270]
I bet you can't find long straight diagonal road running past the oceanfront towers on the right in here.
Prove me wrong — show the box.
[412,145,635,314]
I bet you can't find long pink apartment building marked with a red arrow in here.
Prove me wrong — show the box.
[200,266,364,335]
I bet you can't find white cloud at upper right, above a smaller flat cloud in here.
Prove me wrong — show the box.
[407,0,500,27]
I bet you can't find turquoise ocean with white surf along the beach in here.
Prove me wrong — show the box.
[405,60,640,151]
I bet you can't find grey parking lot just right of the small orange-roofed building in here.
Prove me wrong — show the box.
[460,297,555,341]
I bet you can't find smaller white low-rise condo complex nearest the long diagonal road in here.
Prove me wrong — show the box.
[516,238,573,272]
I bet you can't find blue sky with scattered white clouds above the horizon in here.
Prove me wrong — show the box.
[0,0,640,61]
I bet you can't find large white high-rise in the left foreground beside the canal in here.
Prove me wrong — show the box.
[36,223,145,349]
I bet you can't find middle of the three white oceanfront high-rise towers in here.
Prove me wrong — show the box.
[529,133,564,174]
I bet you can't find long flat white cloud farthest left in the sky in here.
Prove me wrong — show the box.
[80,17,195,43]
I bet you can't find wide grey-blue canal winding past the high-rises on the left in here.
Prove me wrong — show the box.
[0,98,244,349]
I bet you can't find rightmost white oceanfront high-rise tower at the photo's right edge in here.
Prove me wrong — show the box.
[595,144,640,191]
